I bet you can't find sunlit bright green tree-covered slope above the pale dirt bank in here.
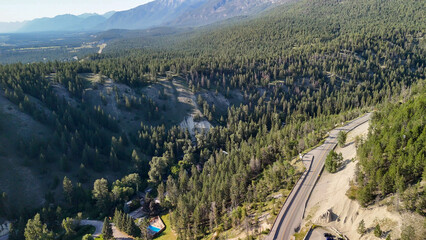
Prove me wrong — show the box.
[357,86,426,215]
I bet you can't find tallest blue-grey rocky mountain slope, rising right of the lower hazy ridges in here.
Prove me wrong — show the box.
[103,0,290,29]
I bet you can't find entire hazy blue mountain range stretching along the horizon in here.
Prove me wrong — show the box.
[0,0,290,33]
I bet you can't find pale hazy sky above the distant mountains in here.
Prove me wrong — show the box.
[0,0,152,22]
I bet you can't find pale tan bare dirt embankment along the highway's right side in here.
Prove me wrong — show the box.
[304,122,423,239]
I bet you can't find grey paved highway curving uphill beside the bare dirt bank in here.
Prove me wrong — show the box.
[266,113,371,240]
